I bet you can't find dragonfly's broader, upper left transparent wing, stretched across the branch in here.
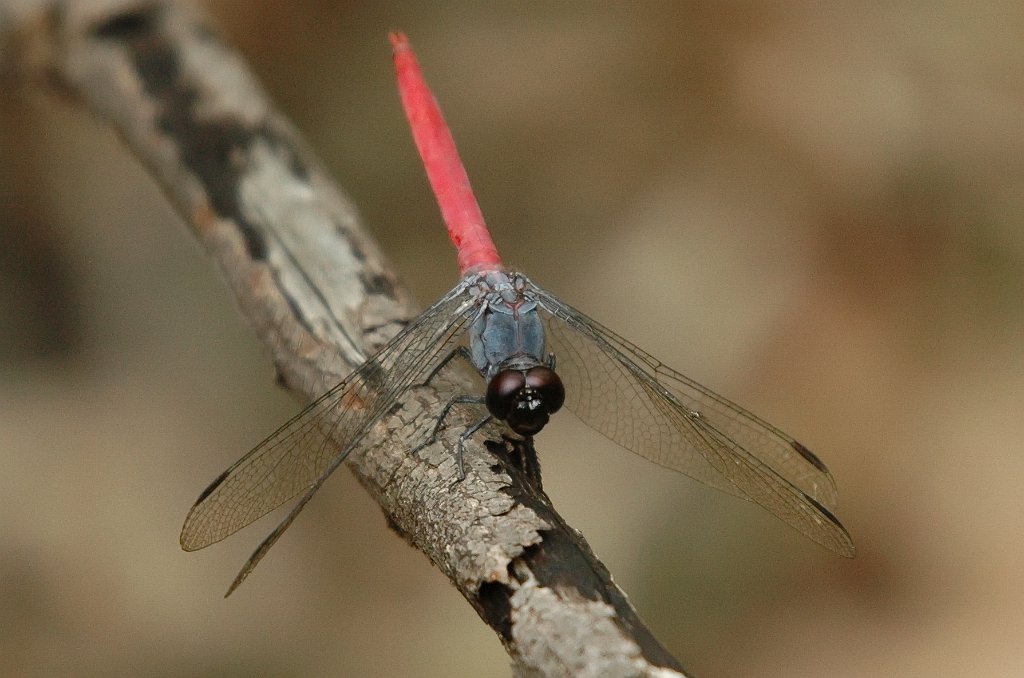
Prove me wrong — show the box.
[181,283,475,551]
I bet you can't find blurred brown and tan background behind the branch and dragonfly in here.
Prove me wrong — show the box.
[0,0,1024,677]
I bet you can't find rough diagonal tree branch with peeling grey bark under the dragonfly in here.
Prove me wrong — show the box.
[0,0,682,676]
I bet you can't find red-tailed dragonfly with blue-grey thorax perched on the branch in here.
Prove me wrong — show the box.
[180,33,854,595]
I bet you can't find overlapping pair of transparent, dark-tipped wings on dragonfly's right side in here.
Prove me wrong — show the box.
[529,283,853,556]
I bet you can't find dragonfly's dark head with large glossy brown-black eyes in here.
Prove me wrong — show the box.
[486,365,565,436]
